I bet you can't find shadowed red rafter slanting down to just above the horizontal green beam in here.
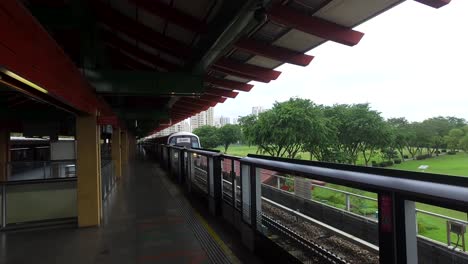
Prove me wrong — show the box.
[102,30,179,71]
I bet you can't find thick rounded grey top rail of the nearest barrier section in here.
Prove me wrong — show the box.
[241,157,468,211]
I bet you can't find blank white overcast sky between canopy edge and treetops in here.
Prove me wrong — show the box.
[215,0,468,121]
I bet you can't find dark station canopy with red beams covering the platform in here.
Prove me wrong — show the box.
[0,0,449,137]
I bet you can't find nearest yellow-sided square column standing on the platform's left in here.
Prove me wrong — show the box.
[76,116,101,227]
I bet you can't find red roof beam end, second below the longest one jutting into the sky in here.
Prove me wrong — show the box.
[214,59,281,83]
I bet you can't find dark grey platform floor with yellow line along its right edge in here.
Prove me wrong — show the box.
[0,161,260,264]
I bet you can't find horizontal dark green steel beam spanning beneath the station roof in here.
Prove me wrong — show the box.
[87,71,205,96]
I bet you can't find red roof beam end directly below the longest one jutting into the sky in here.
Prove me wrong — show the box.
[234,38,314,66]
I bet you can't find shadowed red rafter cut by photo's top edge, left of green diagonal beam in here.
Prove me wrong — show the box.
[130,0,207,33]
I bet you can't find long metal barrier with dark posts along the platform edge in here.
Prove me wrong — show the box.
[155,146,468,263]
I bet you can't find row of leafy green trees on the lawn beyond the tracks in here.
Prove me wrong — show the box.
[240,98,468,165]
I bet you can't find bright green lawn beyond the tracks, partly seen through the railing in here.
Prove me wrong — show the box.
[218,145,468,243]
